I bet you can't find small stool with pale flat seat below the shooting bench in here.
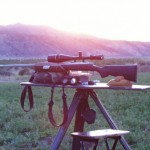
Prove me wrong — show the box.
[71,129,129,150]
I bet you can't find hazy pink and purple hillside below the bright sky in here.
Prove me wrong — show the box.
[0,24,150,59]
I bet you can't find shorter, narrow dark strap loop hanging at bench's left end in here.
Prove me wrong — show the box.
[20,74,34,112]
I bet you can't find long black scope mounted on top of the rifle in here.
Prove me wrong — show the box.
[47,52,104,63]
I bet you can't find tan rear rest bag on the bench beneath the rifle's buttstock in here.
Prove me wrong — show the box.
[107,76,132,86]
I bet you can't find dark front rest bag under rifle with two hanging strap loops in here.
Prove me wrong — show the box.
[20,72,68,127]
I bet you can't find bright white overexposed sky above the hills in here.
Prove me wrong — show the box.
[0,0,150,41]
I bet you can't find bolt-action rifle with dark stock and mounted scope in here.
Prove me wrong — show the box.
[0,52,137,82]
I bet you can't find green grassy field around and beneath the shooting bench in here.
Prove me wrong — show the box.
[0,58,150,150]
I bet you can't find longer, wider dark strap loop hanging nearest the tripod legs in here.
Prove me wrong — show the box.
[48,86,68,127]
